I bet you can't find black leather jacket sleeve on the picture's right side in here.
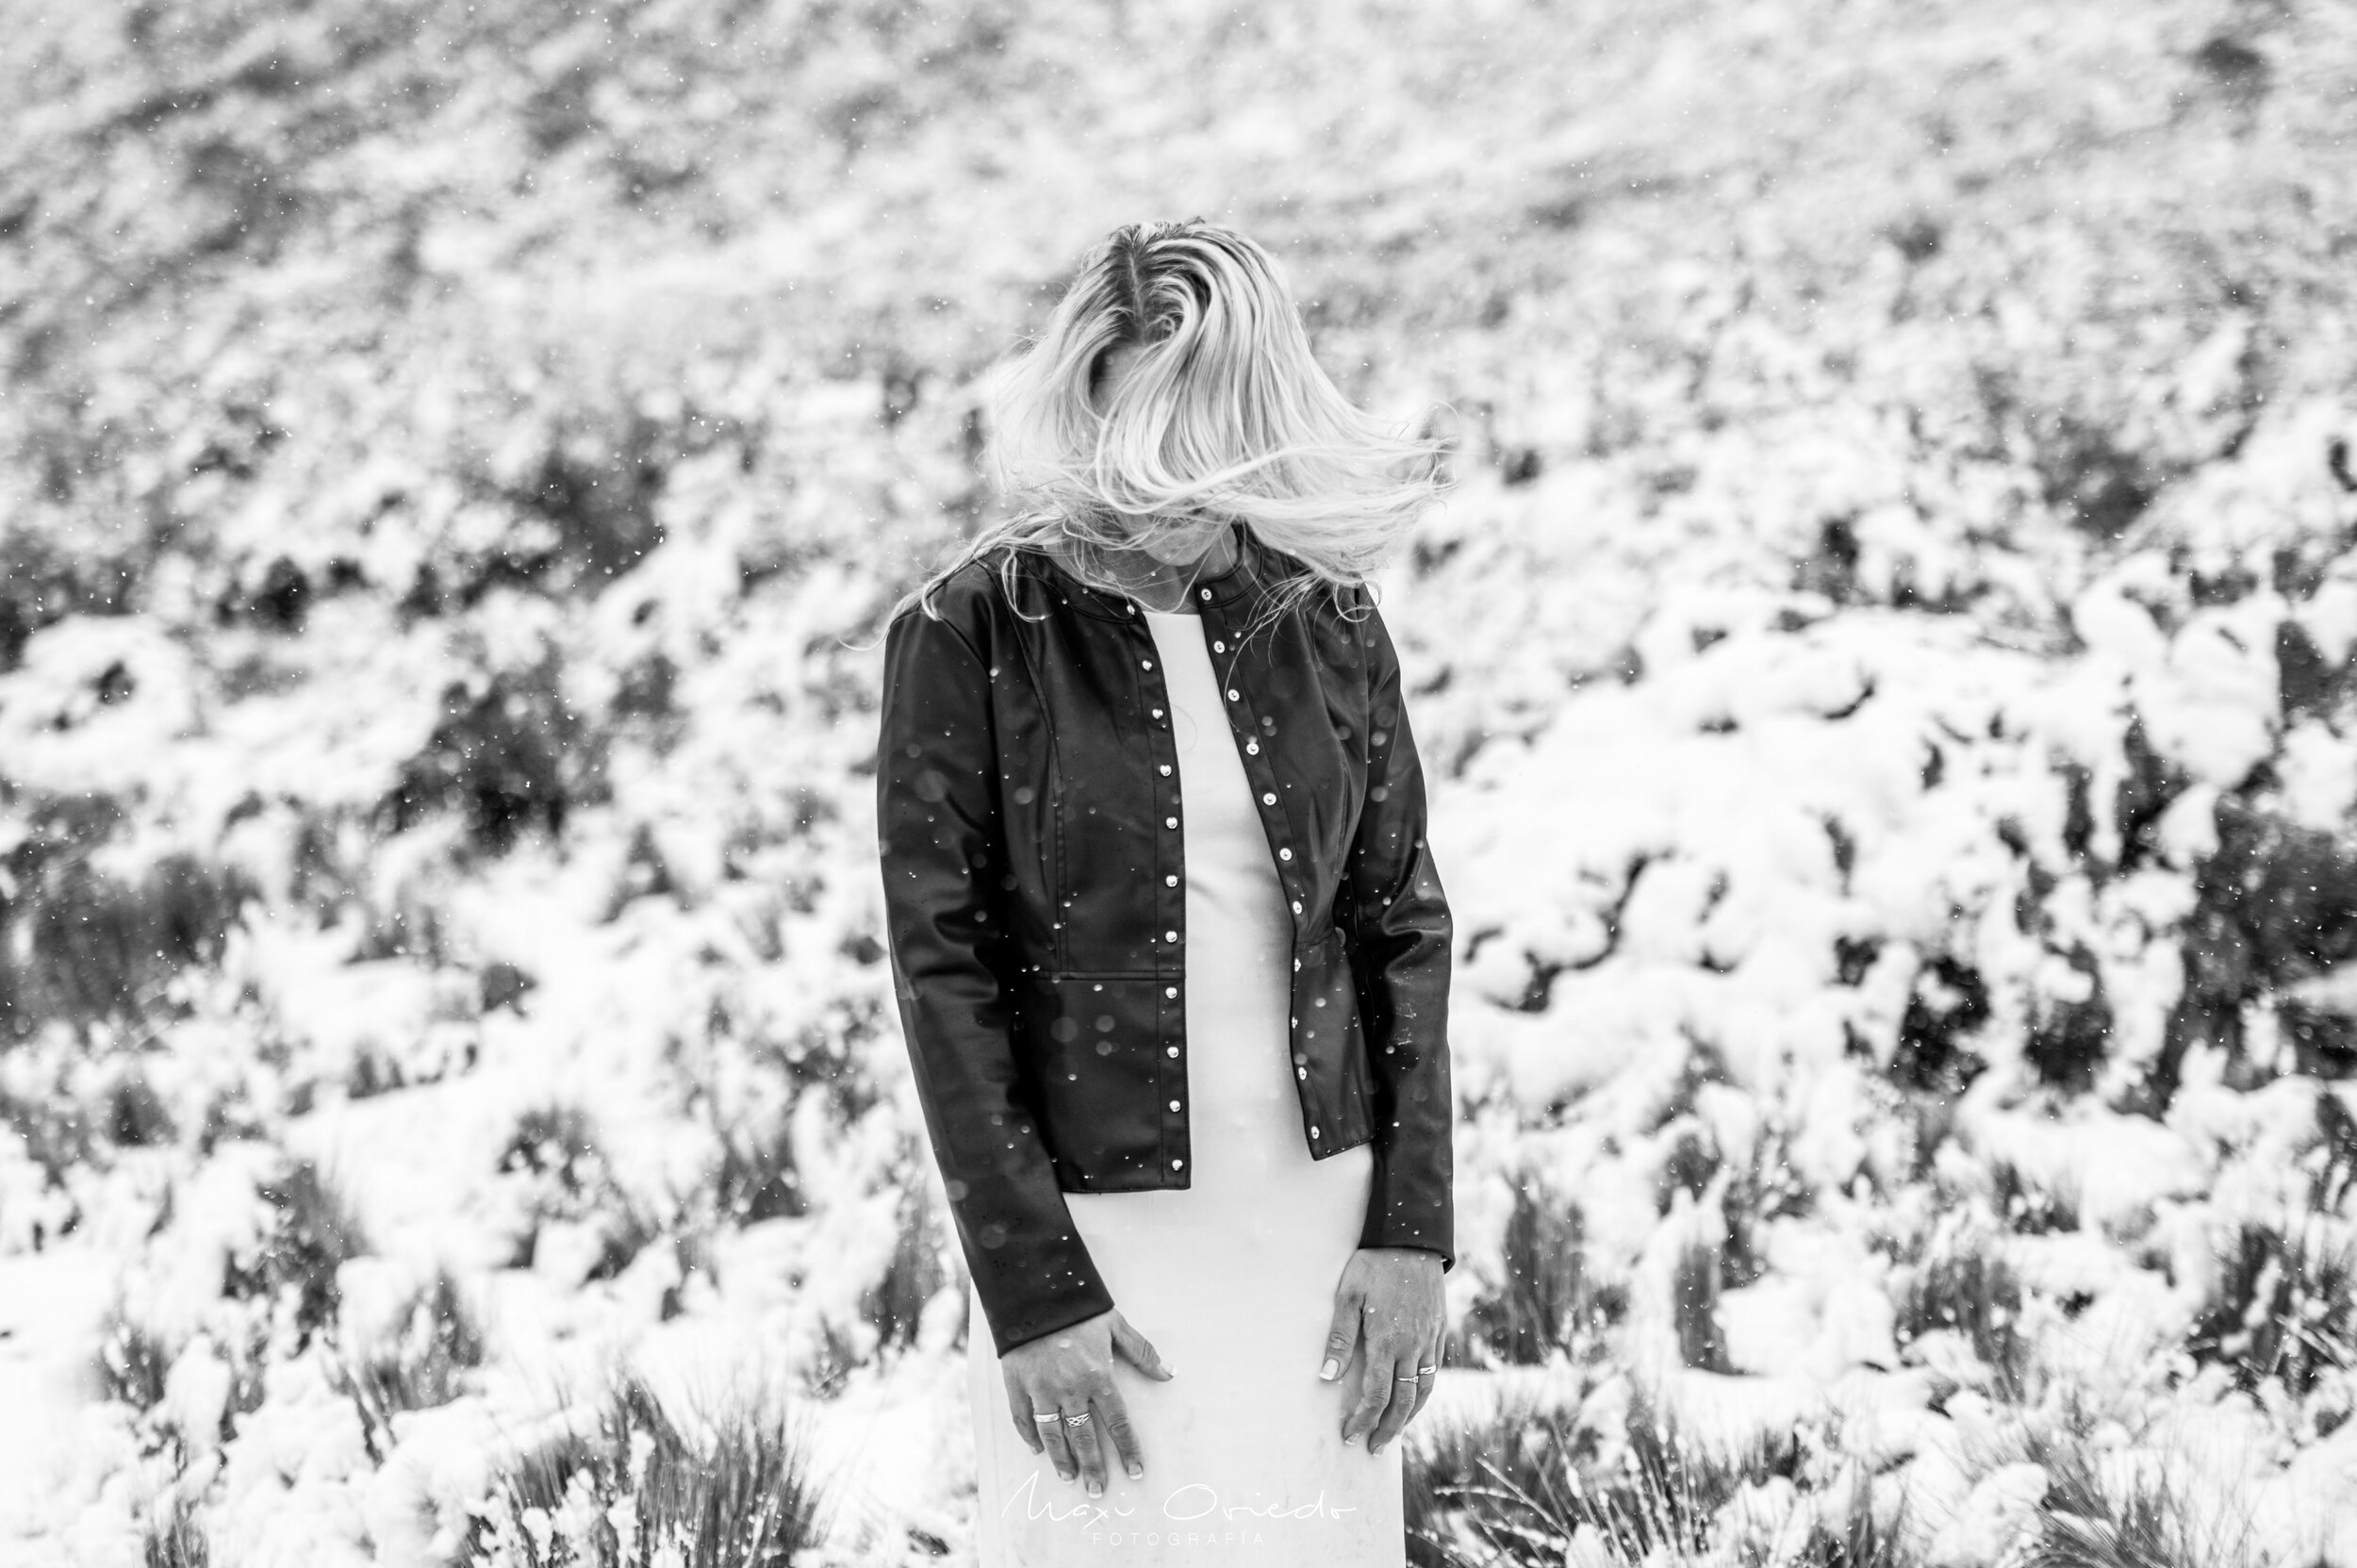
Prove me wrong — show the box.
[1343,599,1457,1271]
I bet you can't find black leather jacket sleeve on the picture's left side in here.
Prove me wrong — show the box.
[877,608,1113,1356]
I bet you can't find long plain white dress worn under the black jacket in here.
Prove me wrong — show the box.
[966,613,1408,1568]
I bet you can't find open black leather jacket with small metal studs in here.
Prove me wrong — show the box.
[877,531,1457,1353]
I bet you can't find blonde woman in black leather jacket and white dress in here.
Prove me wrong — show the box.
[877,220,1455,1568]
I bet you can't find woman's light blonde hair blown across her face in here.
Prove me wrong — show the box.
[900,217,1447,636]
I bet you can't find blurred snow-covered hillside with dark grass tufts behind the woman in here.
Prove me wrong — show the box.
[0,0,2357,1568]
